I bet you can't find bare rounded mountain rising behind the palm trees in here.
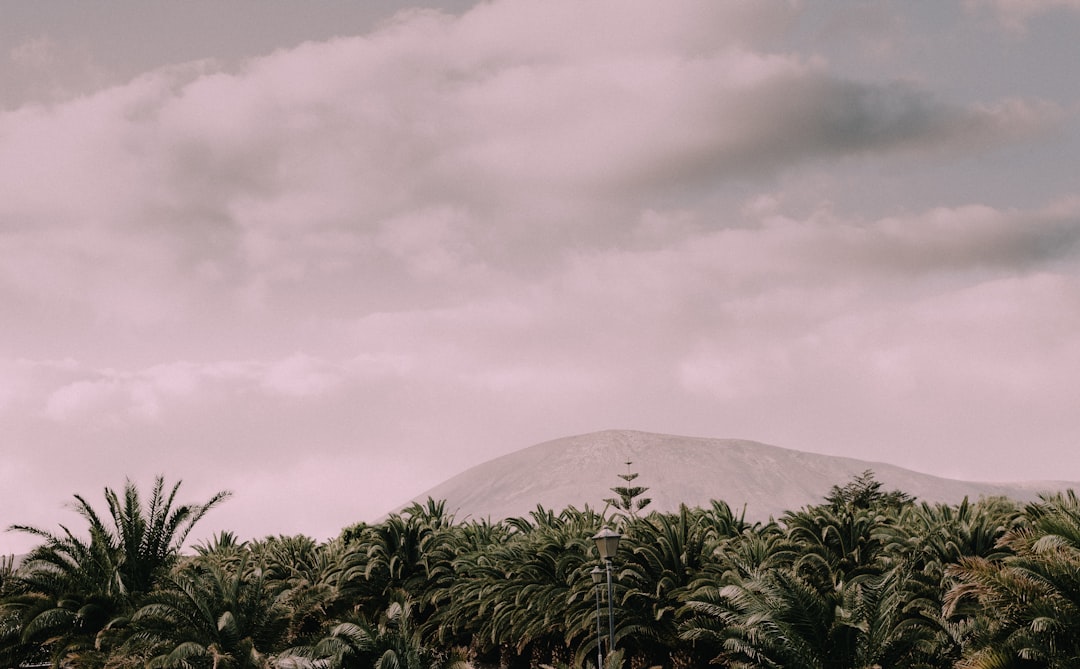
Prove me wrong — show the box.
[415,430,1080,521]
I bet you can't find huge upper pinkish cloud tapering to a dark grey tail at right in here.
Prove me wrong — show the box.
[0,3,1061,345]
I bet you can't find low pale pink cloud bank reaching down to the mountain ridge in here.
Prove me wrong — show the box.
[5,197,1080,553]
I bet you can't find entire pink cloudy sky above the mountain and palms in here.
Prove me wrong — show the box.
[0,0,1080,553]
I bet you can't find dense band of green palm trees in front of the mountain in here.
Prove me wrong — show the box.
[0,472,1080,669]
